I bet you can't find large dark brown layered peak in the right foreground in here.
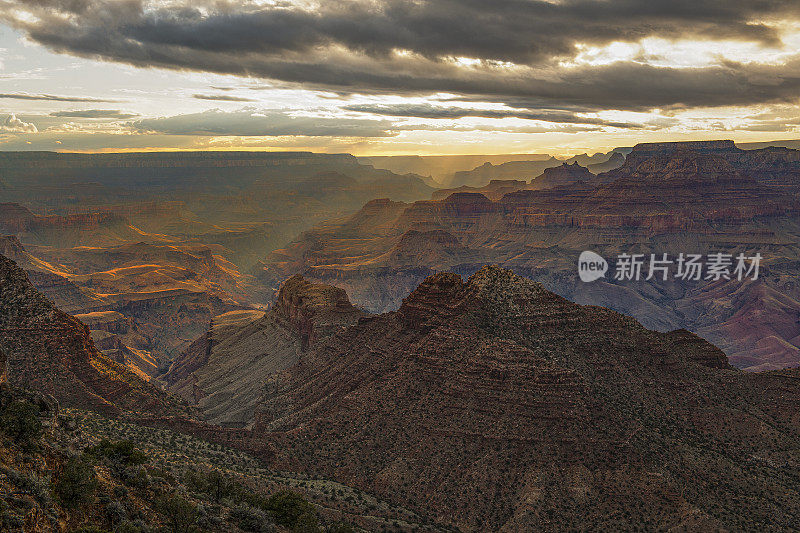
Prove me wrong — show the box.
[253,267,800,531]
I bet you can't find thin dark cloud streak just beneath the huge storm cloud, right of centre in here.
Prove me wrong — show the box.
[342,104,642,128]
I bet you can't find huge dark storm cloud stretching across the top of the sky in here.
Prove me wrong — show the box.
[0,0,800,110]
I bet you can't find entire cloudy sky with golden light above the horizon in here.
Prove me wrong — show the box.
[0,0,800,155]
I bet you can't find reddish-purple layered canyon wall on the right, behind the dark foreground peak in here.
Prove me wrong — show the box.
[255,141,800,370]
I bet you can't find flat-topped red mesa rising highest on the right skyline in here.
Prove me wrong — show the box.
[501,151,800,233]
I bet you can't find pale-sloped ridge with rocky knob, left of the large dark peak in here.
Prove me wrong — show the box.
[162,276,363,427]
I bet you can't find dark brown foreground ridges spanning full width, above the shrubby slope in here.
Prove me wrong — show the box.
[0,248,800,531]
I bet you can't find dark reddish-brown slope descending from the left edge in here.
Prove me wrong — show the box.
[0,256,175,414]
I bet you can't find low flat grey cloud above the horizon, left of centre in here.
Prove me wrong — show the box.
[131,109,392,137]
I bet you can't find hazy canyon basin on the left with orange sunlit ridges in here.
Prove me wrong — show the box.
[0,152,434,379]
